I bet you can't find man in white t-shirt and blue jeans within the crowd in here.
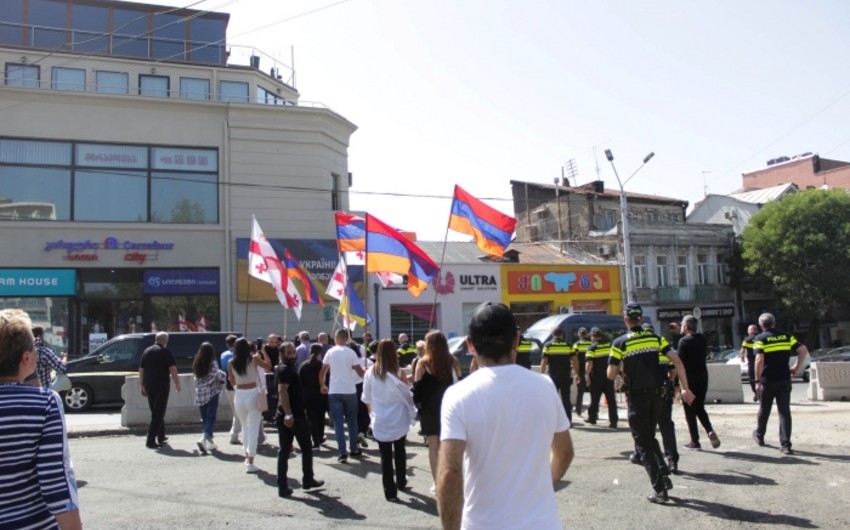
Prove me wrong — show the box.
[319,329,365,464]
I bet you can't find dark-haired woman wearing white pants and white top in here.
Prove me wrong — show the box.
[227,337,271,473]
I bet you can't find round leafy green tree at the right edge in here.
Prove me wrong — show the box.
[743,189,850,332]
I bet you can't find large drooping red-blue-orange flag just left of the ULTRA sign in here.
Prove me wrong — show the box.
[366,213,440,296]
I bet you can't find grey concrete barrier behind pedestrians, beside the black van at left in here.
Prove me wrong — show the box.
[121,374,233,428]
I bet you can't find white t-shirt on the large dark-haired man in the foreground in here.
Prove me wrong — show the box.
[440,364,570,529]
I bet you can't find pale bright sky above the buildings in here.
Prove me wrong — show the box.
[200,0,850,241]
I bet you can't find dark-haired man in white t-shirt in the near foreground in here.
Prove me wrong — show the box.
[437,302,574,529]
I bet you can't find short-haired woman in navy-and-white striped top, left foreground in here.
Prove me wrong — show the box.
[0,309,82,529]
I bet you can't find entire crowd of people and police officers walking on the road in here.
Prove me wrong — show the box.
[0,303,808,528]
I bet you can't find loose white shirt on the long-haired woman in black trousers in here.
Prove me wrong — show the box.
[360,367,416,442]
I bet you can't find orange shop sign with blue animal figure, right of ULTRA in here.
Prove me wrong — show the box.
[508,270,611,294]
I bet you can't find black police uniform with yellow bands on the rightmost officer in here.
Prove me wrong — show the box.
[753,328,802,450]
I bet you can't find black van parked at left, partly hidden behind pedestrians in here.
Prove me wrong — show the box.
[54,331,242,412]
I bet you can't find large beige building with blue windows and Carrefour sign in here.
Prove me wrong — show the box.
[0,0,355,355]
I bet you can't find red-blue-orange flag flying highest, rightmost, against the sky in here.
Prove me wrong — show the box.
[449,184,516,257]
